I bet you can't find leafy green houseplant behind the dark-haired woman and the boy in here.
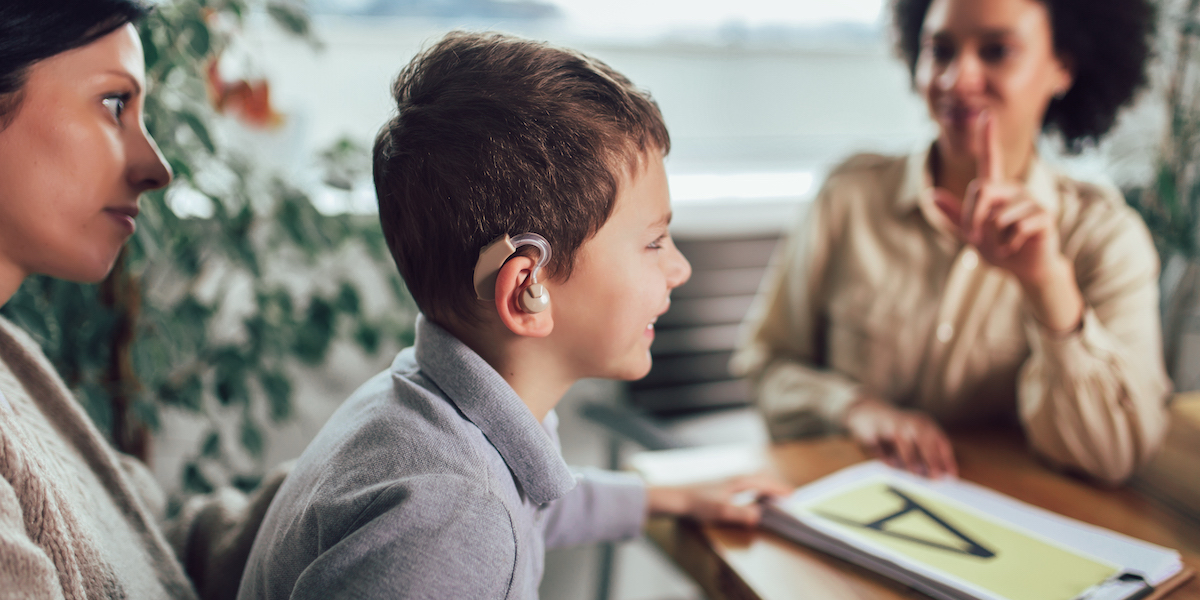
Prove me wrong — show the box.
[0,0,414,491]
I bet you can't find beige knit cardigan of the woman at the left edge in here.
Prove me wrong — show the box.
[0,319,197,600]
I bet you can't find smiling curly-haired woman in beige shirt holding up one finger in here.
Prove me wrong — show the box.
[733,0,1170,484]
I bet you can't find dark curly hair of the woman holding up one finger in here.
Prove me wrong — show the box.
[892,0,1154,152]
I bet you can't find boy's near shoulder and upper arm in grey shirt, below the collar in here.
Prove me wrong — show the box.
[244,349,521,598]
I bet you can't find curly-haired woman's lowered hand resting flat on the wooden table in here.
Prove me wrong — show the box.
[844,397,959,478]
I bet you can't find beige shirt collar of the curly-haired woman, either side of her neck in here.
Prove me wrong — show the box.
[894,143,1061,226]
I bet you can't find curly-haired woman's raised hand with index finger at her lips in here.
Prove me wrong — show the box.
[934,113,1084,332]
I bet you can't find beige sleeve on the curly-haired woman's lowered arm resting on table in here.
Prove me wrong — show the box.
[731,182,859,439]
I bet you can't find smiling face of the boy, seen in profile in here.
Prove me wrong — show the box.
[548,150,691,379]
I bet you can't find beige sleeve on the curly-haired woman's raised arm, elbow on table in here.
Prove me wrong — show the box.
[1018,199,1171,484]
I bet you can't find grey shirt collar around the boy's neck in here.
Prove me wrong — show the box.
[414,316,575,504]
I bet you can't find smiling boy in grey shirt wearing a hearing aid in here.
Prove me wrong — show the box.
[239,32,786,599]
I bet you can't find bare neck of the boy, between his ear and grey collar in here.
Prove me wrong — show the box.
[451,328,577,422]
